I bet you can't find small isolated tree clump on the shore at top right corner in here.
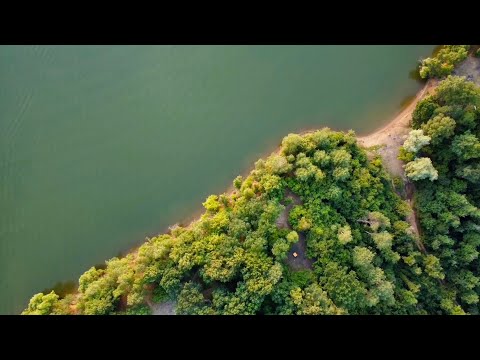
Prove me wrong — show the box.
[420,45,470,79]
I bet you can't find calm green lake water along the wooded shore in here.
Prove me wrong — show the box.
[0,45,434,314]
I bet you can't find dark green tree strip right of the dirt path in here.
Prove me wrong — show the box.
[404,76,480,314]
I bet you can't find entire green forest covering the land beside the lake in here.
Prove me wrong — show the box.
[23,46,480,315]
